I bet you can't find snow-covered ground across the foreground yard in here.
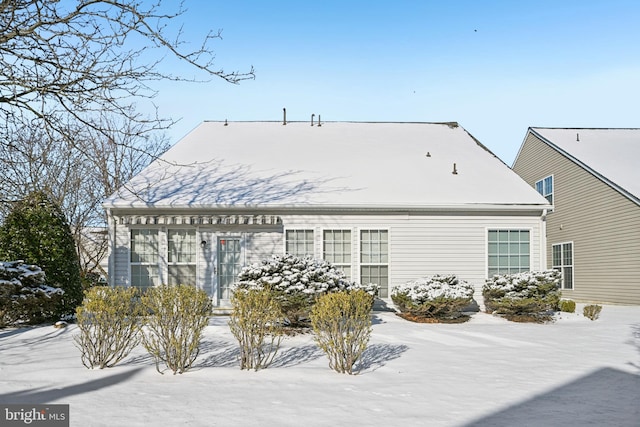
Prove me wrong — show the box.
[0,305,640,426]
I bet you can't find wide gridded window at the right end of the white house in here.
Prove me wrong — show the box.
[487,230,531,277]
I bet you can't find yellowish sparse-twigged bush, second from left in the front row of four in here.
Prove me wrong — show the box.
[141,285,211,375]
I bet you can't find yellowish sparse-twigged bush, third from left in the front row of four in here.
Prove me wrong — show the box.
[229,289,283,371]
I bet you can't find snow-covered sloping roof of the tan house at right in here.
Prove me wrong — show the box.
[530,128,640,203]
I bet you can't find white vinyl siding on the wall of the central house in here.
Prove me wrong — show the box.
[110,212,551,304]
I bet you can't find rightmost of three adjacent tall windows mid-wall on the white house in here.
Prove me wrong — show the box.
[360,230,389,298]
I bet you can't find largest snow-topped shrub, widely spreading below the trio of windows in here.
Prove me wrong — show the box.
[234,255,378,326]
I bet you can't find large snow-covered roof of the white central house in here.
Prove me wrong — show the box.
[104,121,547,209]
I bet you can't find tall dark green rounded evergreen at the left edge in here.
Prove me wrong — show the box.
[0,191,82,315]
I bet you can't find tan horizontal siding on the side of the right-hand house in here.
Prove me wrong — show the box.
[513,134,640,304]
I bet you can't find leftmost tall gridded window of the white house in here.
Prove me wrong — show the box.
[130,229,160,289]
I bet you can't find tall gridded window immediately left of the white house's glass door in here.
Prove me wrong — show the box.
[167,230,196,286]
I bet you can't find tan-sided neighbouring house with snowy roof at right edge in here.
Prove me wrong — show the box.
[513,128,640,304]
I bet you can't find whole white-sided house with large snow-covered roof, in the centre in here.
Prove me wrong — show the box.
[104,121,550,305]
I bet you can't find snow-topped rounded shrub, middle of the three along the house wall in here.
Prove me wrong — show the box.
[391,274,474,320]
